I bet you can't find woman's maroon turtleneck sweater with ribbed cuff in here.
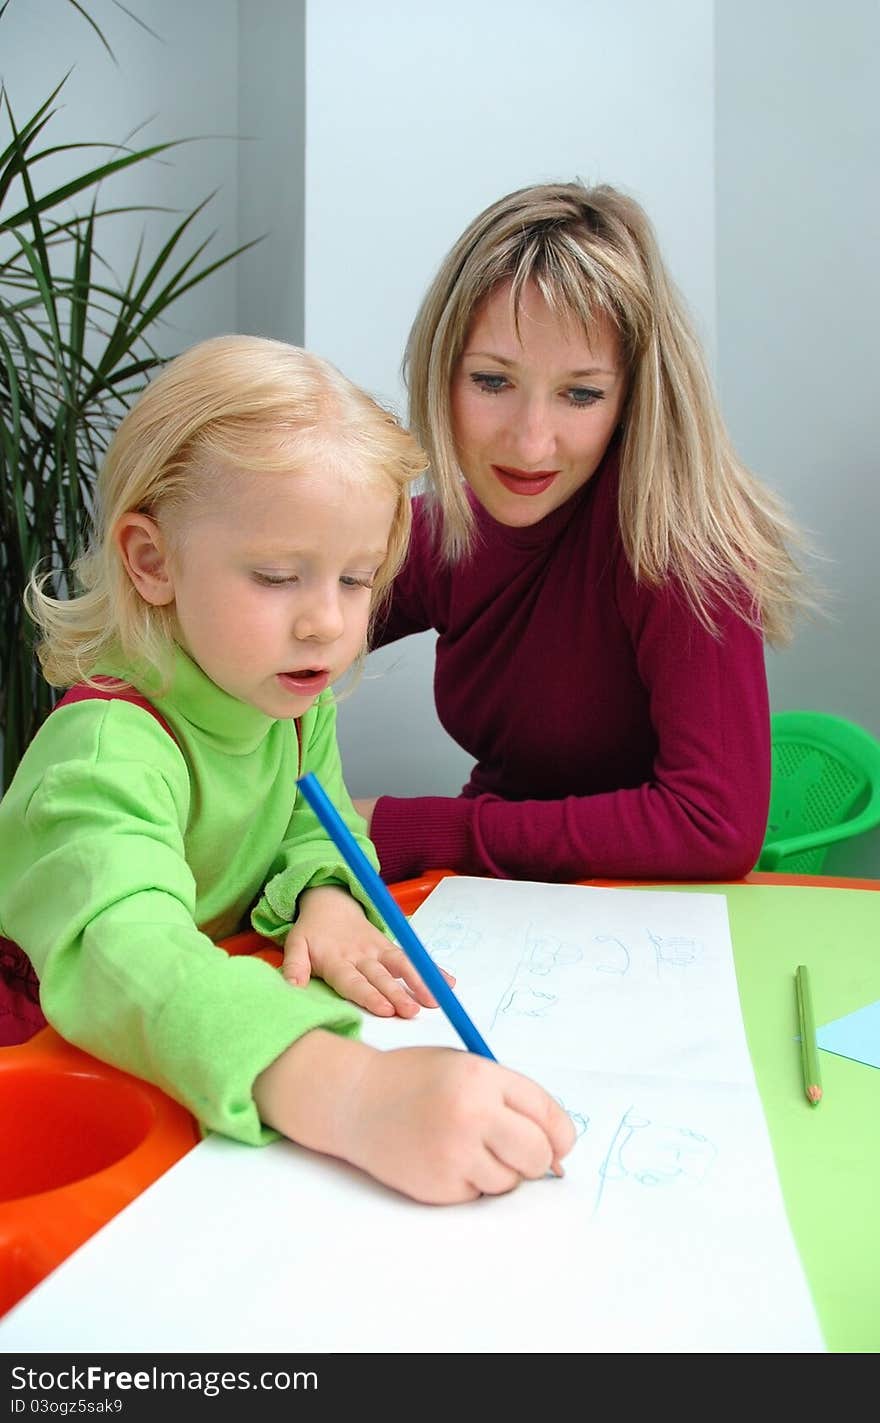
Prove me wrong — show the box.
[370,453,770,881]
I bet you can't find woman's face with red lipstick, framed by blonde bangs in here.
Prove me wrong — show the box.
[450,282,627,528]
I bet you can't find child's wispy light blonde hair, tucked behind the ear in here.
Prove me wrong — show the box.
[26,336,427,689]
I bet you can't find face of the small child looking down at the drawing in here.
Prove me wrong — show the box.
[168,462,397,719]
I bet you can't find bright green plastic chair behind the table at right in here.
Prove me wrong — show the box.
[755,712,880,875]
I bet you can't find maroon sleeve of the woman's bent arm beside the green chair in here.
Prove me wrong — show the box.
[370,586,770,881]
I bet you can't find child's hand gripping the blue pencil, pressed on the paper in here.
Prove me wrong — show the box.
[253,1029,575,1205]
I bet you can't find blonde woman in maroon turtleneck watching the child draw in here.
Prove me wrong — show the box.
[357,182,799,879]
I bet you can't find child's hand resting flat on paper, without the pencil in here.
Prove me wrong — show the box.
[282,885,456,1017]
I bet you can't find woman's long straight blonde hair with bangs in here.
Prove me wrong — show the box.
[404,182,806,642]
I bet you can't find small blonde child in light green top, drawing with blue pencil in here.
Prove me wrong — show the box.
[0,336,574,1202]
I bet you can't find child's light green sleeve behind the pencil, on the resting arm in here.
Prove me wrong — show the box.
[251,693,387,943]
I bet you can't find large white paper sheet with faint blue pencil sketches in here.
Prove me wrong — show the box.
[0,878,823,1353]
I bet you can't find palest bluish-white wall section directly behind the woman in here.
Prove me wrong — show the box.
[306,0,715,794]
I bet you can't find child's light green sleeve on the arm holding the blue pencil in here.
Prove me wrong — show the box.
[0,717,360,1144]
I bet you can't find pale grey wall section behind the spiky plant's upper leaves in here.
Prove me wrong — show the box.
[0,0,239,354]
